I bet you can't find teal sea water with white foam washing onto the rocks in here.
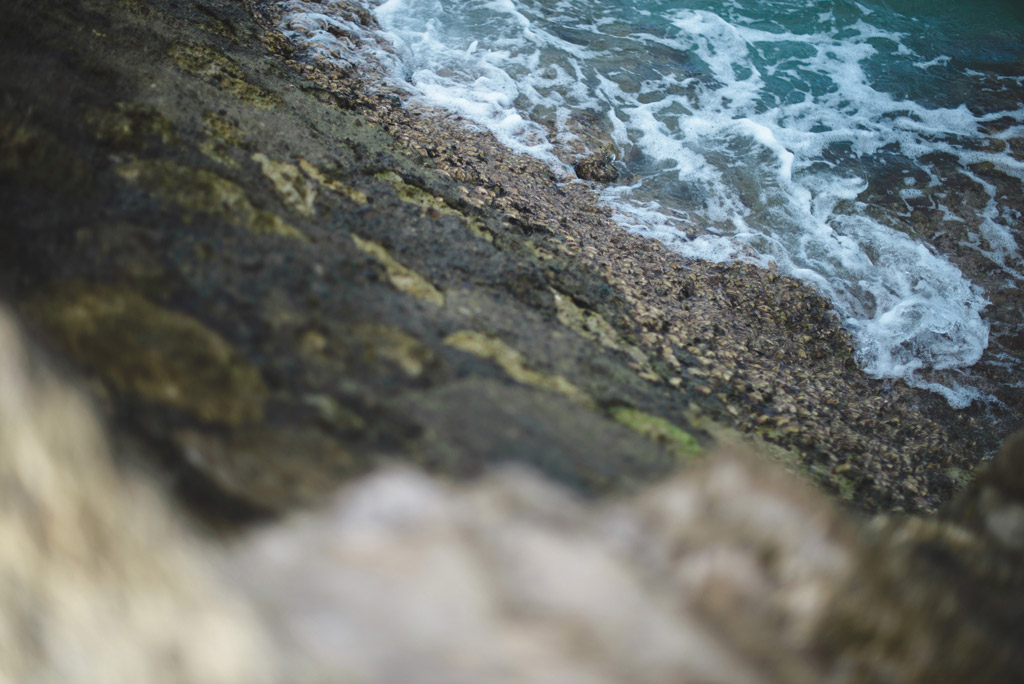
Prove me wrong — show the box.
[274,0,1024,408]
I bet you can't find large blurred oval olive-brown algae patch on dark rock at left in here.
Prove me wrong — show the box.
[29,285,267,426]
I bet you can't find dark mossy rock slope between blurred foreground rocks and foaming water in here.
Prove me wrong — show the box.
[0,0,1019,516]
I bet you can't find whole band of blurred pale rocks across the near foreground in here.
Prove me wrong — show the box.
[0,311,1024,684]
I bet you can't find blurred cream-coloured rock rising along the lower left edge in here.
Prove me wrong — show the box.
[0,310,274,684]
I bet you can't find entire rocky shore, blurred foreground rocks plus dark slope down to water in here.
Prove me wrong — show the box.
[6,0,1024,683]
